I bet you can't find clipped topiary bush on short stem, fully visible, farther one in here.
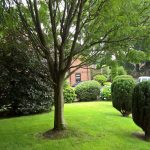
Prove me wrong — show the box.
[111,78,135,116]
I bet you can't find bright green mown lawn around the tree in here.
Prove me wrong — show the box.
[0,102,150,150]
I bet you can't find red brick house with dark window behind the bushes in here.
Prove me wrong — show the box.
[68,59,91,86]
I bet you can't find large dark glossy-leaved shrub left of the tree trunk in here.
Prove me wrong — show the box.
[0,36,53,116]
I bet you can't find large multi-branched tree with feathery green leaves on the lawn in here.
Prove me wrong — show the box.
[4,0,149,131]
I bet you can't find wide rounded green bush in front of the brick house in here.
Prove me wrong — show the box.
[75,80,100,101]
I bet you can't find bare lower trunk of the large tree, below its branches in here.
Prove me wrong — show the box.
[54,77,66,131]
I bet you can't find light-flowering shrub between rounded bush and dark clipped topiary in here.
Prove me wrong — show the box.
[100,86,111,100]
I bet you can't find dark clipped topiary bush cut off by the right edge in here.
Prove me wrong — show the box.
[132,81,150,141]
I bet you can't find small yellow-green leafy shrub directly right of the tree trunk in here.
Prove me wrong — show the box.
[64,86,76,103]
